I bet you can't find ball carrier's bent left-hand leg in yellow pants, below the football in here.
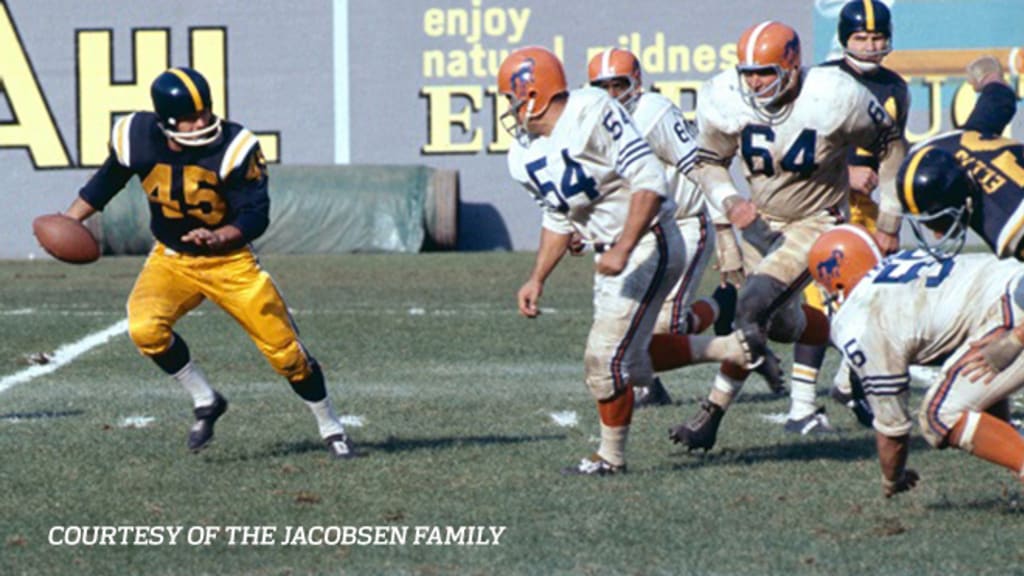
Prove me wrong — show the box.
[127,244,227,450]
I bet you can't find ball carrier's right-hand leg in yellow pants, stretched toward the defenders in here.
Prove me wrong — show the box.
[205,250,356,458]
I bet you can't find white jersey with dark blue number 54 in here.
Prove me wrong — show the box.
[508,87,676,244]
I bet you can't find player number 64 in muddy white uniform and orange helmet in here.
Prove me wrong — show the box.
[670,20,904,450]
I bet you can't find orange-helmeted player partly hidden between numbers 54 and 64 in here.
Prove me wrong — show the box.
[587,48,742,408]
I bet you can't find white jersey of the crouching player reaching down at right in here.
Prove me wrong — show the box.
[830,250,1024,436]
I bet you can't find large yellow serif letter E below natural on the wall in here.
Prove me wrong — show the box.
[420,86,483,154]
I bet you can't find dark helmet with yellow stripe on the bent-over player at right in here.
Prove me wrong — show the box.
[896,146,976,259]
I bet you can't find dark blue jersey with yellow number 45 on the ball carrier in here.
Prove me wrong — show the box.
[79,112,270,253]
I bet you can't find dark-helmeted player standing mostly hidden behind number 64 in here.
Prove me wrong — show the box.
[784,0,910,435]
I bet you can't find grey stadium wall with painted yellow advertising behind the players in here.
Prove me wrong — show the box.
[0,0,1024,258]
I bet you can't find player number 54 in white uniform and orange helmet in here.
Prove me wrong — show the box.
[498,46,746,476]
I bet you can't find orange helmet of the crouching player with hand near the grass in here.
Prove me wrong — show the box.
[807,224,882,303]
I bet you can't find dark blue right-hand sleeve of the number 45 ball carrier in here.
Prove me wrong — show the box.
[224,145,270,242]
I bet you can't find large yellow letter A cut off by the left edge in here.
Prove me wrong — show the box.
[0,2,71,168]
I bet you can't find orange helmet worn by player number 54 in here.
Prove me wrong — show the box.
[498,46,568,141]
